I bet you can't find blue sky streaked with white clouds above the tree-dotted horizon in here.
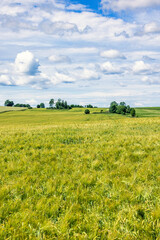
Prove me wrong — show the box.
[0,0,160,107]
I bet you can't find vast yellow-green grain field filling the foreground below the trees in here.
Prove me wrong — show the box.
[0,108,160,240]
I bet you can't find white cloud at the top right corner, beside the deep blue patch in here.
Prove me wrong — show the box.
[101,0,160,11]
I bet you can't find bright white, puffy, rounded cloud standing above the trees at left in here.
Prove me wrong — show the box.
[15,51,40,76]
